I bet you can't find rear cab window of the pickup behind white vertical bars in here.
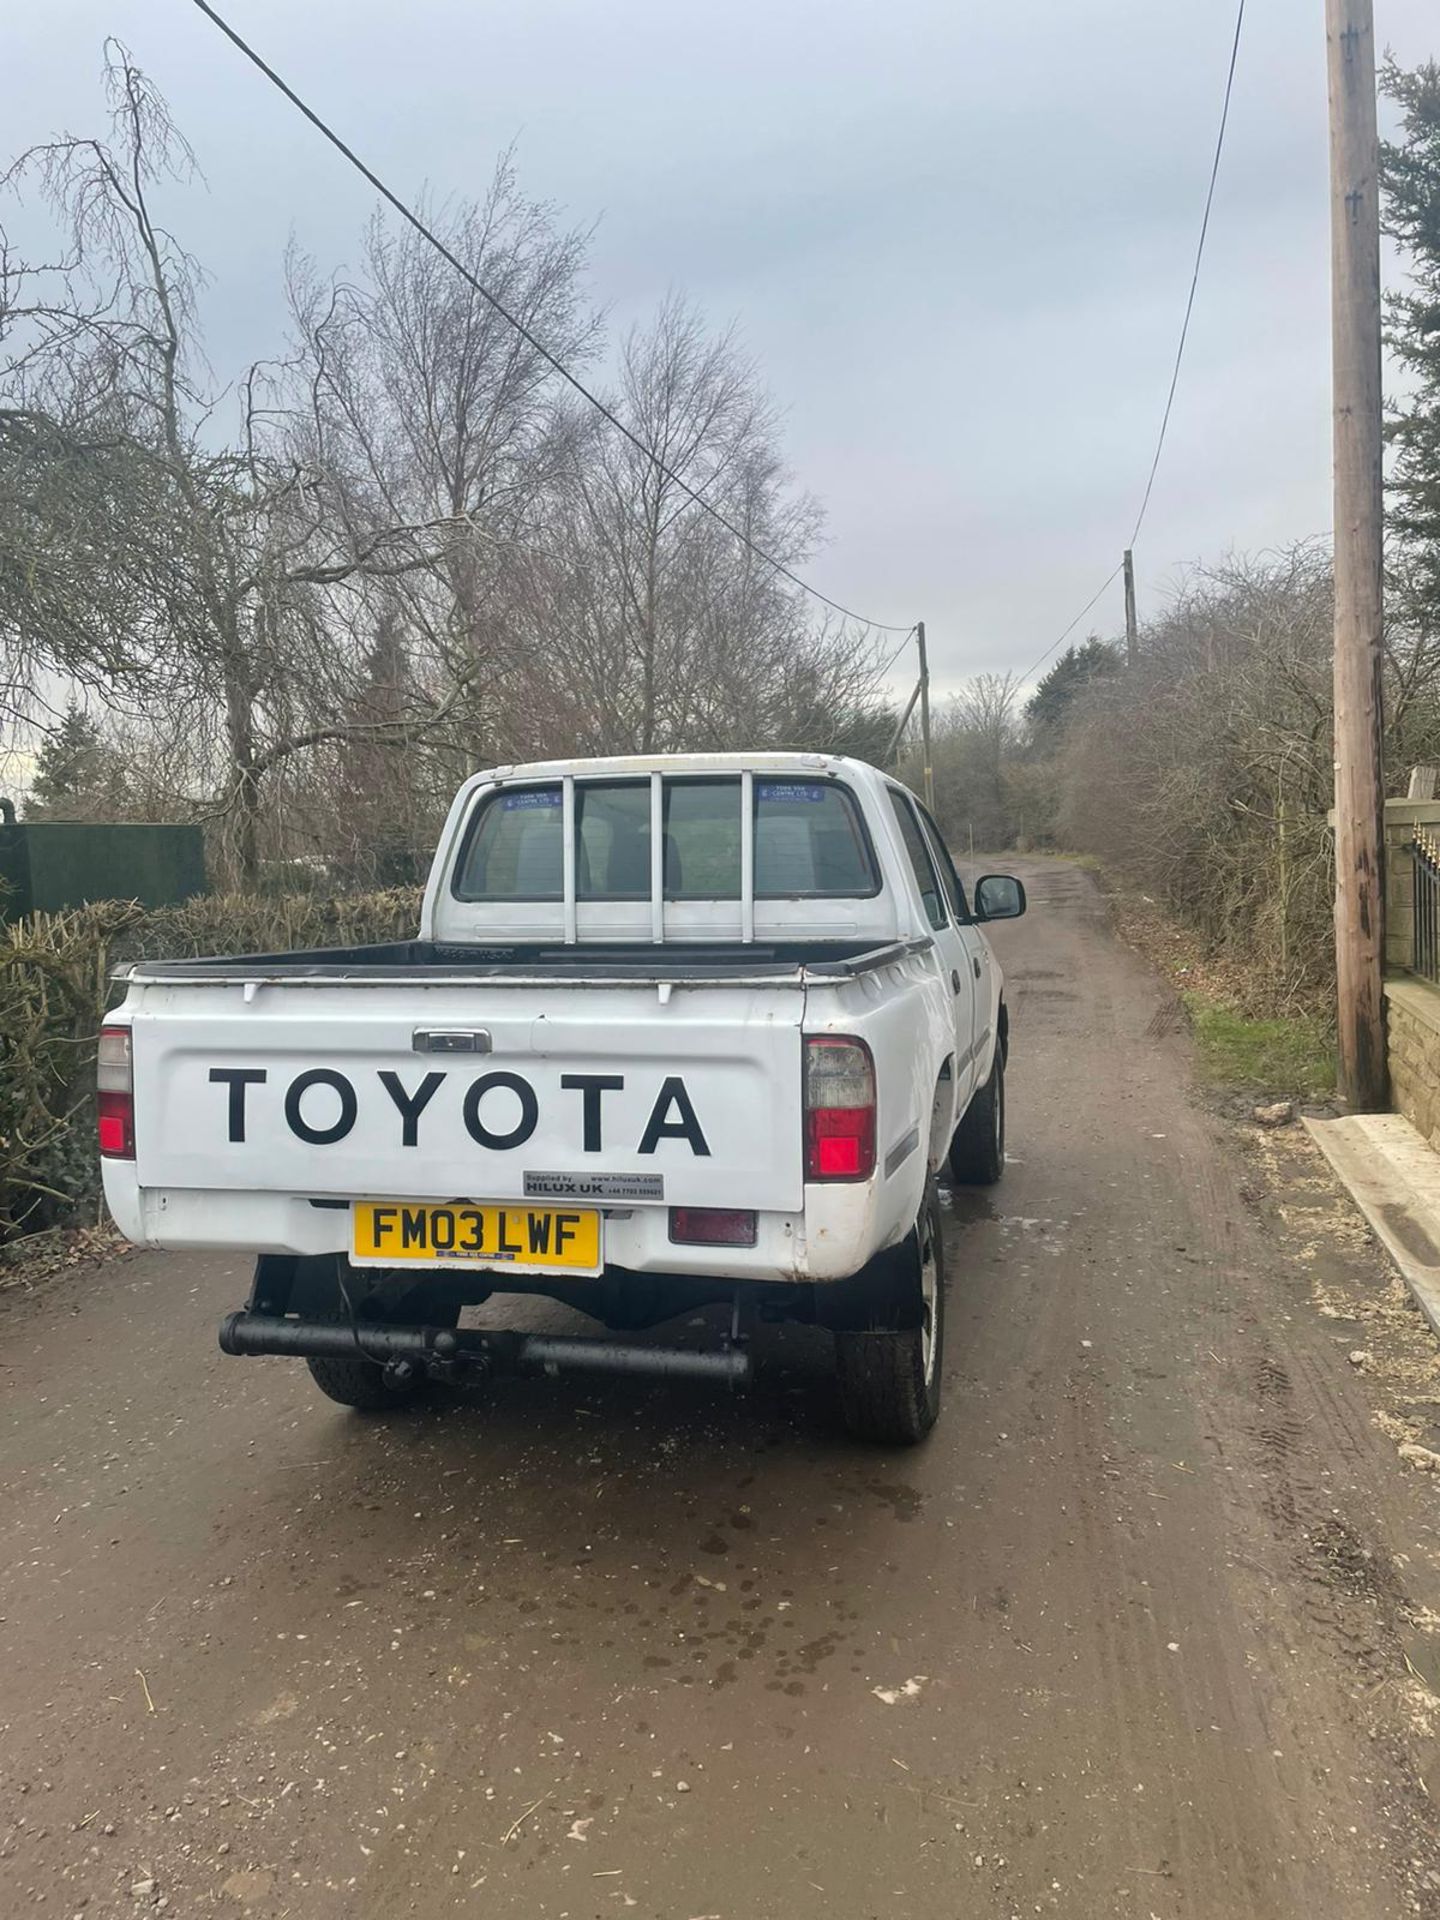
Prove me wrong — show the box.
[451,774,879,902]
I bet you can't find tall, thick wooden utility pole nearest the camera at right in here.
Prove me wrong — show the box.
[1325,0,1388,1114]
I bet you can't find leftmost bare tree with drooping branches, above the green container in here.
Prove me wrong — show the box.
[0,42,495,879]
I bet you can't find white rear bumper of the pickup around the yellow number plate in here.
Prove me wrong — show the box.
[106,1154,922,1292]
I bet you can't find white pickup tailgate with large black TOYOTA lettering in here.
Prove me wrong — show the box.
[132,981,804,1212]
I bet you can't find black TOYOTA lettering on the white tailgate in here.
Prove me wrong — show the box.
[209,1068,710,1158]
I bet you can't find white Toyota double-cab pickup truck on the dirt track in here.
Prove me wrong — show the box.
[98,753,1025,1442]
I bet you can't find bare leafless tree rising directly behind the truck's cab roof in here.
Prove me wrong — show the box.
[536,298,849,753]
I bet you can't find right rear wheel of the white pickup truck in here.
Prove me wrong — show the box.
[835,1181,945,1446]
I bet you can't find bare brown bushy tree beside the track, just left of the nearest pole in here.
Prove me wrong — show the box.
[1060,545,1332,1004]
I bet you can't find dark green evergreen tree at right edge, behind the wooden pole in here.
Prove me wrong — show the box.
[1380,61,1440,630]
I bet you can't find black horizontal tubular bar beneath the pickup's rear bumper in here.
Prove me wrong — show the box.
[221,1311,751,1386]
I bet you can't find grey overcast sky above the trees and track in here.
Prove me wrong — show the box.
[0,0,1440,706]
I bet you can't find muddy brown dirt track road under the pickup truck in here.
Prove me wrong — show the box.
[0,862,1440,1920]
